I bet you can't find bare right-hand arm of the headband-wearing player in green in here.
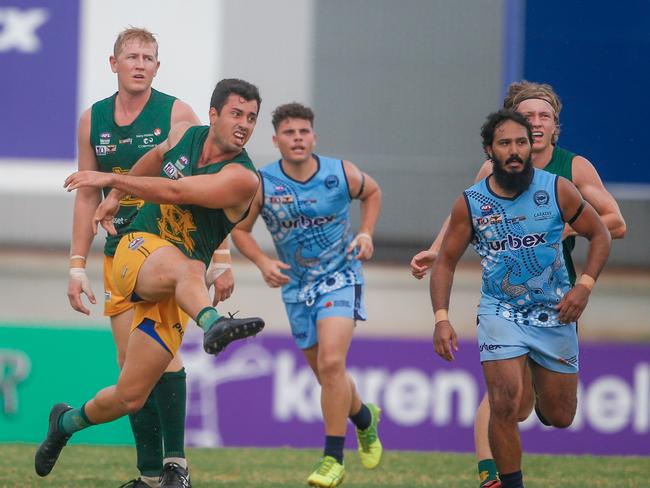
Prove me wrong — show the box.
[572,156,626,239]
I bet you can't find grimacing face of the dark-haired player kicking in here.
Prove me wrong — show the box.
[210,93,259,152]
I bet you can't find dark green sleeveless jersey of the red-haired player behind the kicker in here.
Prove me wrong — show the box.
[90,89,176,256]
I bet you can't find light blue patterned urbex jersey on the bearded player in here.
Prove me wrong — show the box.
[464,169,570,327]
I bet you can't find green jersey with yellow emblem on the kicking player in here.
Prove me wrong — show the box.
[129,126,256,266]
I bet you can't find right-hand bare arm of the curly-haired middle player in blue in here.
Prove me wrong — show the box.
[343,161,381,260]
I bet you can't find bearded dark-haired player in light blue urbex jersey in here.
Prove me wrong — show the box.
[431,110,611,488]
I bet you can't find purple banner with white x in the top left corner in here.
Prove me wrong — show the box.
[0,0,79,159]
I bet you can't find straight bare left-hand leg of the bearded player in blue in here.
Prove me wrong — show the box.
[483,356,526,473]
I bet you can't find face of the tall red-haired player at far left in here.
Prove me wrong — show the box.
[110,40,160,93]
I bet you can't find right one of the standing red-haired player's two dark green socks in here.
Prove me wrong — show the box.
[154,368,187,458]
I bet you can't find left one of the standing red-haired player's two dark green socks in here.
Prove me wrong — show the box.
[129,392,162,477]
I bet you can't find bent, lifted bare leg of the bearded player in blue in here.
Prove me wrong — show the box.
[530,361,578,429]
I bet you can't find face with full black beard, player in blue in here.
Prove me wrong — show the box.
[488,120,533,193]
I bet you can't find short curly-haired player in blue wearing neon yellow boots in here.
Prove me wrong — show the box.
[232,103,382,487]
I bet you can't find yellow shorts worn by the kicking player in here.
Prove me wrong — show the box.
[113,232,188,355]
